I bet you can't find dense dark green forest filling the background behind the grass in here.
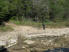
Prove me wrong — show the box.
[0,0,69,25]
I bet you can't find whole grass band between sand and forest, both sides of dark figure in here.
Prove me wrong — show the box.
[11,19,69,28]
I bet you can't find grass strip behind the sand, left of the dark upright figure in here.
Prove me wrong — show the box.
[10,19,41,27]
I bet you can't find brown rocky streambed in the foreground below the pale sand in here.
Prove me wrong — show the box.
[9,35,69,52]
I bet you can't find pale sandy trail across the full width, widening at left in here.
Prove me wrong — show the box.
[0,23,69,45]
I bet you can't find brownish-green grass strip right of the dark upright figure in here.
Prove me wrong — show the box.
[46,21,69,28]
